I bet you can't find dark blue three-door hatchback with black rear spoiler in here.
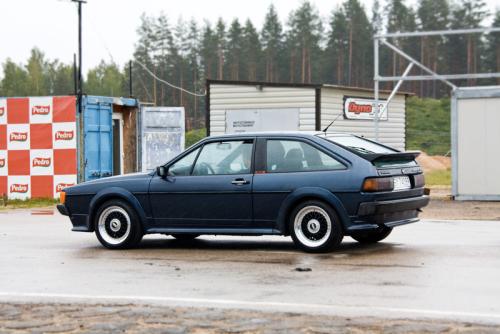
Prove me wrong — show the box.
[58,132,429,252]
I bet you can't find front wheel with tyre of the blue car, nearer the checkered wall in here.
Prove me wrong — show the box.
[95,200,143,249]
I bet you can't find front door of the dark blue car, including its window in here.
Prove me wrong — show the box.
[150,138,255,229]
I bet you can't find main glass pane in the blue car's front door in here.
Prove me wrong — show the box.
[193,140,253,175]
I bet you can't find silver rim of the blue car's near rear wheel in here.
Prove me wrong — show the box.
[293,205,332,247]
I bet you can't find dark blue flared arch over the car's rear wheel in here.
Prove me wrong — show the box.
[277,187,350,235]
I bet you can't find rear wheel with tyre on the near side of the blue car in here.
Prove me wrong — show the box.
[290,200,344,253]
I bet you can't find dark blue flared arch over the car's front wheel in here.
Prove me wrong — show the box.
[88,187,146,232]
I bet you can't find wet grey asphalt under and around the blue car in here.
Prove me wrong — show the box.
[0,210,500,325]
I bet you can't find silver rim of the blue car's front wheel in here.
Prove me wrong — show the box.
[98,206,130,245]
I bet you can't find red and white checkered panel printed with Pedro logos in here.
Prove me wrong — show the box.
[0,96,77,199]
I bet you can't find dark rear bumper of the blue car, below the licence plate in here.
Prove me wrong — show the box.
[348,195,429,231]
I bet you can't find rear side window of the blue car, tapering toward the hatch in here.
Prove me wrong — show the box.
[266,139,345,173]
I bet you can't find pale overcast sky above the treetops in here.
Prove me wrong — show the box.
[0,0,500,73]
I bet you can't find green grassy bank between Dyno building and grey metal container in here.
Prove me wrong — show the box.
[406,97,450,155]
